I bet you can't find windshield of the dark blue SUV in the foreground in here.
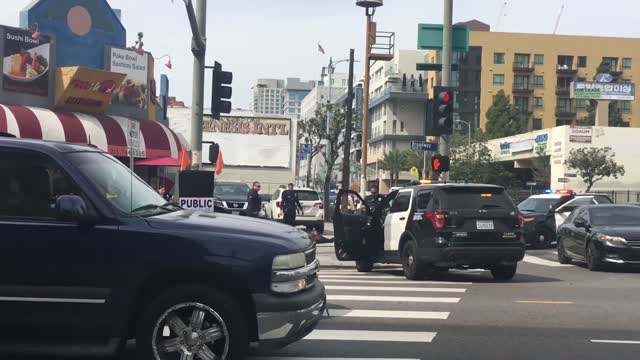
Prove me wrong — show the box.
[68,152,171,214]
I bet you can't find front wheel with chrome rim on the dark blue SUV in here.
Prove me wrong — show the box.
[136,286,249,360]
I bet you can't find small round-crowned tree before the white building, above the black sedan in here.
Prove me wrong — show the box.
[565,147,626,192]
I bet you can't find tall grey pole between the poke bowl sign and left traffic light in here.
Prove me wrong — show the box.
[184,0,207,170]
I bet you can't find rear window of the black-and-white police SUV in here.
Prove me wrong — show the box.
[442,187,516,210]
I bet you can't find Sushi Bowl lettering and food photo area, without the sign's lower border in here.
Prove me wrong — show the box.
[2,27,52,97]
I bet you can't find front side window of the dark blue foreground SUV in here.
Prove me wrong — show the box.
[0,151,82,219]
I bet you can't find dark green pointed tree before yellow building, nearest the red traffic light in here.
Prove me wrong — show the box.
[487,90,528,139]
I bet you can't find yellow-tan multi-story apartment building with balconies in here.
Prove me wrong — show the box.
[427,26,640,130]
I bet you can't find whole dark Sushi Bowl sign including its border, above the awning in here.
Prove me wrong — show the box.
[0,27,55,106]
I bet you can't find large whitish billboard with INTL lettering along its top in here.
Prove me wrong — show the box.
[202,115,291,168]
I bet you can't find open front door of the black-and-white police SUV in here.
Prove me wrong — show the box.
[333,190,371,261]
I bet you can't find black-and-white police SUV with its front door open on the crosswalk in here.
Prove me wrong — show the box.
[333,184,525,280]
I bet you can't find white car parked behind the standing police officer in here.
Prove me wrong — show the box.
[265,188,324,233]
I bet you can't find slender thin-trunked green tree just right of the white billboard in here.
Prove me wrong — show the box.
[304,104,353,219]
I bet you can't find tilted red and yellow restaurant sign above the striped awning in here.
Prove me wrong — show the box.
[54,66,126,113]
